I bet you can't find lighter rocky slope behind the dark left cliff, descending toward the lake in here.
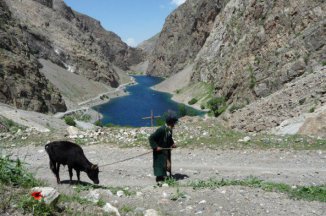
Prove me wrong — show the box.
[4,0,143,87]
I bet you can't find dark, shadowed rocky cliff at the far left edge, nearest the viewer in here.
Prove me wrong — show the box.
[0,0,66,113]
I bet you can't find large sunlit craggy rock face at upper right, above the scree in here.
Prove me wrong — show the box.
[193,0,326,103]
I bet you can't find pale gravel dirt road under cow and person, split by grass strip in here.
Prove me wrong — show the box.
[5,145,326,216]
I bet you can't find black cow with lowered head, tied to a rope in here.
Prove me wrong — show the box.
[45,141,99,184]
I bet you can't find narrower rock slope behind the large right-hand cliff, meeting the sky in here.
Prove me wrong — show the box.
[147,0,227,76]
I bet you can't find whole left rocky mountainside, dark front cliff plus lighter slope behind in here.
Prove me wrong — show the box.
[0,0,143,113]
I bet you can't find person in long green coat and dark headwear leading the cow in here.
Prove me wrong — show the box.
[149,114,178,183]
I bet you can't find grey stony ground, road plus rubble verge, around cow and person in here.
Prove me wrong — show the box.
[1,117,326,215]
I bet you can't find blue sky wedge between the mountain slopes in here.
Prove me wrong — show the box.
[64,0,186,47]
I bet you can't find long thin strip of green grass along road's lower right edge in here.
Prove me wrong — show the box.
[186,177,326,202]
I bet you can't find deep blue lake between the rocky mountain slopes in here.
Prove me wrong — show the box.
[94,76,203,127]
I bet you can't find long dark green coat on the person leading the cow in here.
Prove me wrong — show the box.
[149,125,174,176]
